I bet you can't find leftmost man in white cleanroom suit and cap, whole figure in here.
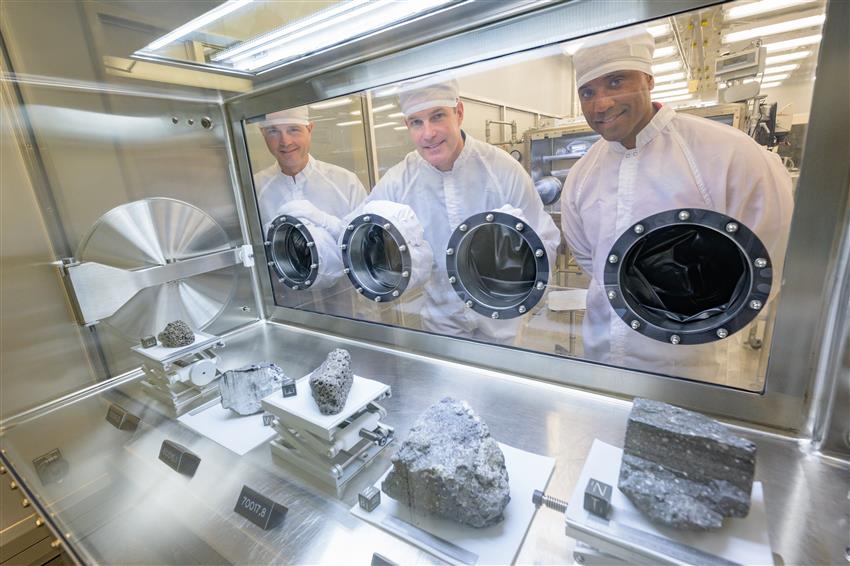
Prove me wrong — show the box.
[254,106,366,316]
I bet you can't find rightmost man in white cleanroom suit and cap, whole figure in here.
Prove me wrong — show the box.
[561,29,793,382]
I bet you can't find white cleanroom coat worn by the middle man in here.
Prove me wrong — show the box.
[367,133,561,343]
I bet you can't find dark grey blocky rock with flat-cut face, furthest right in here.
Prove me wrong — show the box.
[619,399,756,530]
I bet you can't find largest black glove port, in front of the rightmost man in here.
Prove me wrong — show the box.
[604,208,773,344]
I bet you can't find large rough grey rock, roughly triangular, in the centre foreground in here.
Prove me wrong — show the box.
[381,397,511,527]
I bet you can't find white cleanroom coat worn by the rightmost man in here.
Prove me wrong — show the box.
[561,106,793,382]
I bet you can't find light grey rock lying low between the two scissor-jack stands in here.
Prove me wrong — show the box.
[219,362,286,415]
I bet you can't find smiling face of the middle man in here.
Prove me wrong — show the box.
[404,102,463,171]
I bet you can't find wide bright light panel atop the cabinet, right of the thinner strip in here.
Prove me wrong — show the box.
[213,0,457,71]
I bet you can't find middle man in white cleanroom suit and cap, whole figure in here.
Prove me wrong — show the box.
[368,78,560,343]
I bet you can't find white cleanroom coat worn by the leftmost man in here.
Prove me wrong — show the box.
[254,155,366,316]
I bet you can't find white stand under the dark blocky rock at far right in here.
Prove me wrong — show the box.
[566,440,773,564]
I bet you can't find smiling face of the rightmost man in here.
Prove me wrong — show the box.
[578,71,655,149]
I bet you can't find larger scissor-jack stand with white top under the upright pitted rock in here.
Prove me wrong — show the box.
[262,375,393,495]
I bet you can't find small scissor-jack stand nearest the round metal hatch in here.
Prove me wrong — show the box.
[132,332,224,417]
